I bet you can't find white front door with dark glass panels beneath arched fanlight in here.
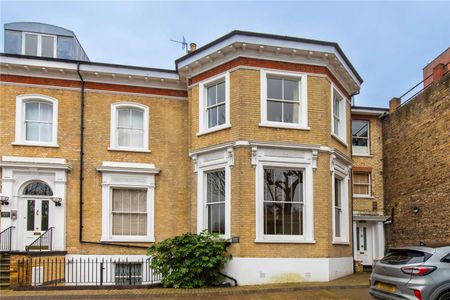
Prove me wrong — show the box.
[24,199,49,246]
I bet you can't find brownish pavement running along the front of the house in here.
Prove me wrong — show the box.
[0,273,372,300]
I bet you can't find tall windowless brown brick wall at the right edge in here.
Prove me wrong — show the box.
[383,73,450,247]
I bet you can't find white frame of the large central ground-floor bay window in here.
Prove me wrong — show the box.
[255,149,316,244]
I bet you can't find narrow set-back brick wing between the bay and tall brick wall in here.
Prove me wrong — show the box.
[352,106,388,266]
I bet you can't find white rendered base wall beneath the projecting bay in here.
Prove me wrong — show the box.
[224,257,353,285]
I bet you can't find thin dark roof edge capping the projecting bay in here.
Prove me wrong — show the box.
[175,30,363,83]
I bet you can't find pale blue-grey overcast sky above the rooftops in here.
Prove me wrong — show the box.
[0,0,450,107]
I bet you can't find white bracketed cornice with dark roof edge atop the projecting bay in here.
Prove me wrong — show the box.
[176,31,362,94]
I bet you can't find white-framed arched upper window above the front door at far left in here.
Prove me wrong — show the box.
[15,95,58,146]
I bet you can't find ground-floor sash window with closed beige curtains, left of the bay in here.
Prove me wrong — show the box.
[112,189,147,236]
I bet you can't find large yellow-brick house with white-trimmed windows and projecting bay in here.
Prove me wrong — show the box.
[0,23,364,284]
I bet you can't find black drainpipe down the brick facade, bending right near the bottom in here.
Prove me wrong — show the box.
[77,61,148,249]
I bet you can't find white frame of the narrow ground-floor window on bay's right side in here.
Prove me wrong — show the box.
[331,158,350,244]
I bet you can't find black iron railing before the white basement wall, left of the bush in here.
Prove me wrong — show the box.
[18,257,161,287]
